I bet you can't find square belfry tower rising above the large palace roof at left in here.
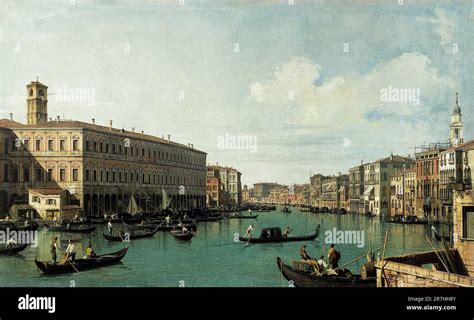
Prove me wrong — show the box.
[26,78,48,125]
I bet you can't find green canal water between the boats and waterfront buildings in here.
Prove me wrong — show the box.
[0,208,436,287]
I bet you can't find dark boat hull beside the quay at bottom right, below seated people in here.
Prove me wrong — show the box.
[277,257,376,288]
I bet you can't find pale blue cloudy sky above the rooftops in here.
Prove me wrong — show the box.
[0,0,474,184]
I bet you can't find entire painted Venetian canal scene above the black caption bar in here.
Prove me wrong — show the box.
[0,0,474,304]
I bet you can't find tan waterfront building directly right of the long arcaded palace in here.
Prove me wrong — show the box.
[207,164,242,206]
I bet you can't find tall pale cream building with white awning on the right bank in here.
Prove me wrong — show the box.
[364,154,414,215]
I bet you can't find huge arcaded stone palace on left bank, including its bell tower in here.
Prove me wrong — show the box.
[0,81,207,219]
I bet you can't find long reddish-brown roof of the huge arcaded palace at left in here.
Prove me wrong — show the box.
[0,119,205,153]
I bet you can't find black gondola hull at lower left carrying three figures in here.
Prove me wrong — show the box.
[35,247,128,274]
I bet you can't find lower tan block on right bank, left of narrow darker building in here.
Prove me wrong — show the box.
[321,174,349,209]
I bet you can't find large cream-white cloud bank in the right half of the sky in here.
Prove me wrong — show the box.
[250,53,453,129]
